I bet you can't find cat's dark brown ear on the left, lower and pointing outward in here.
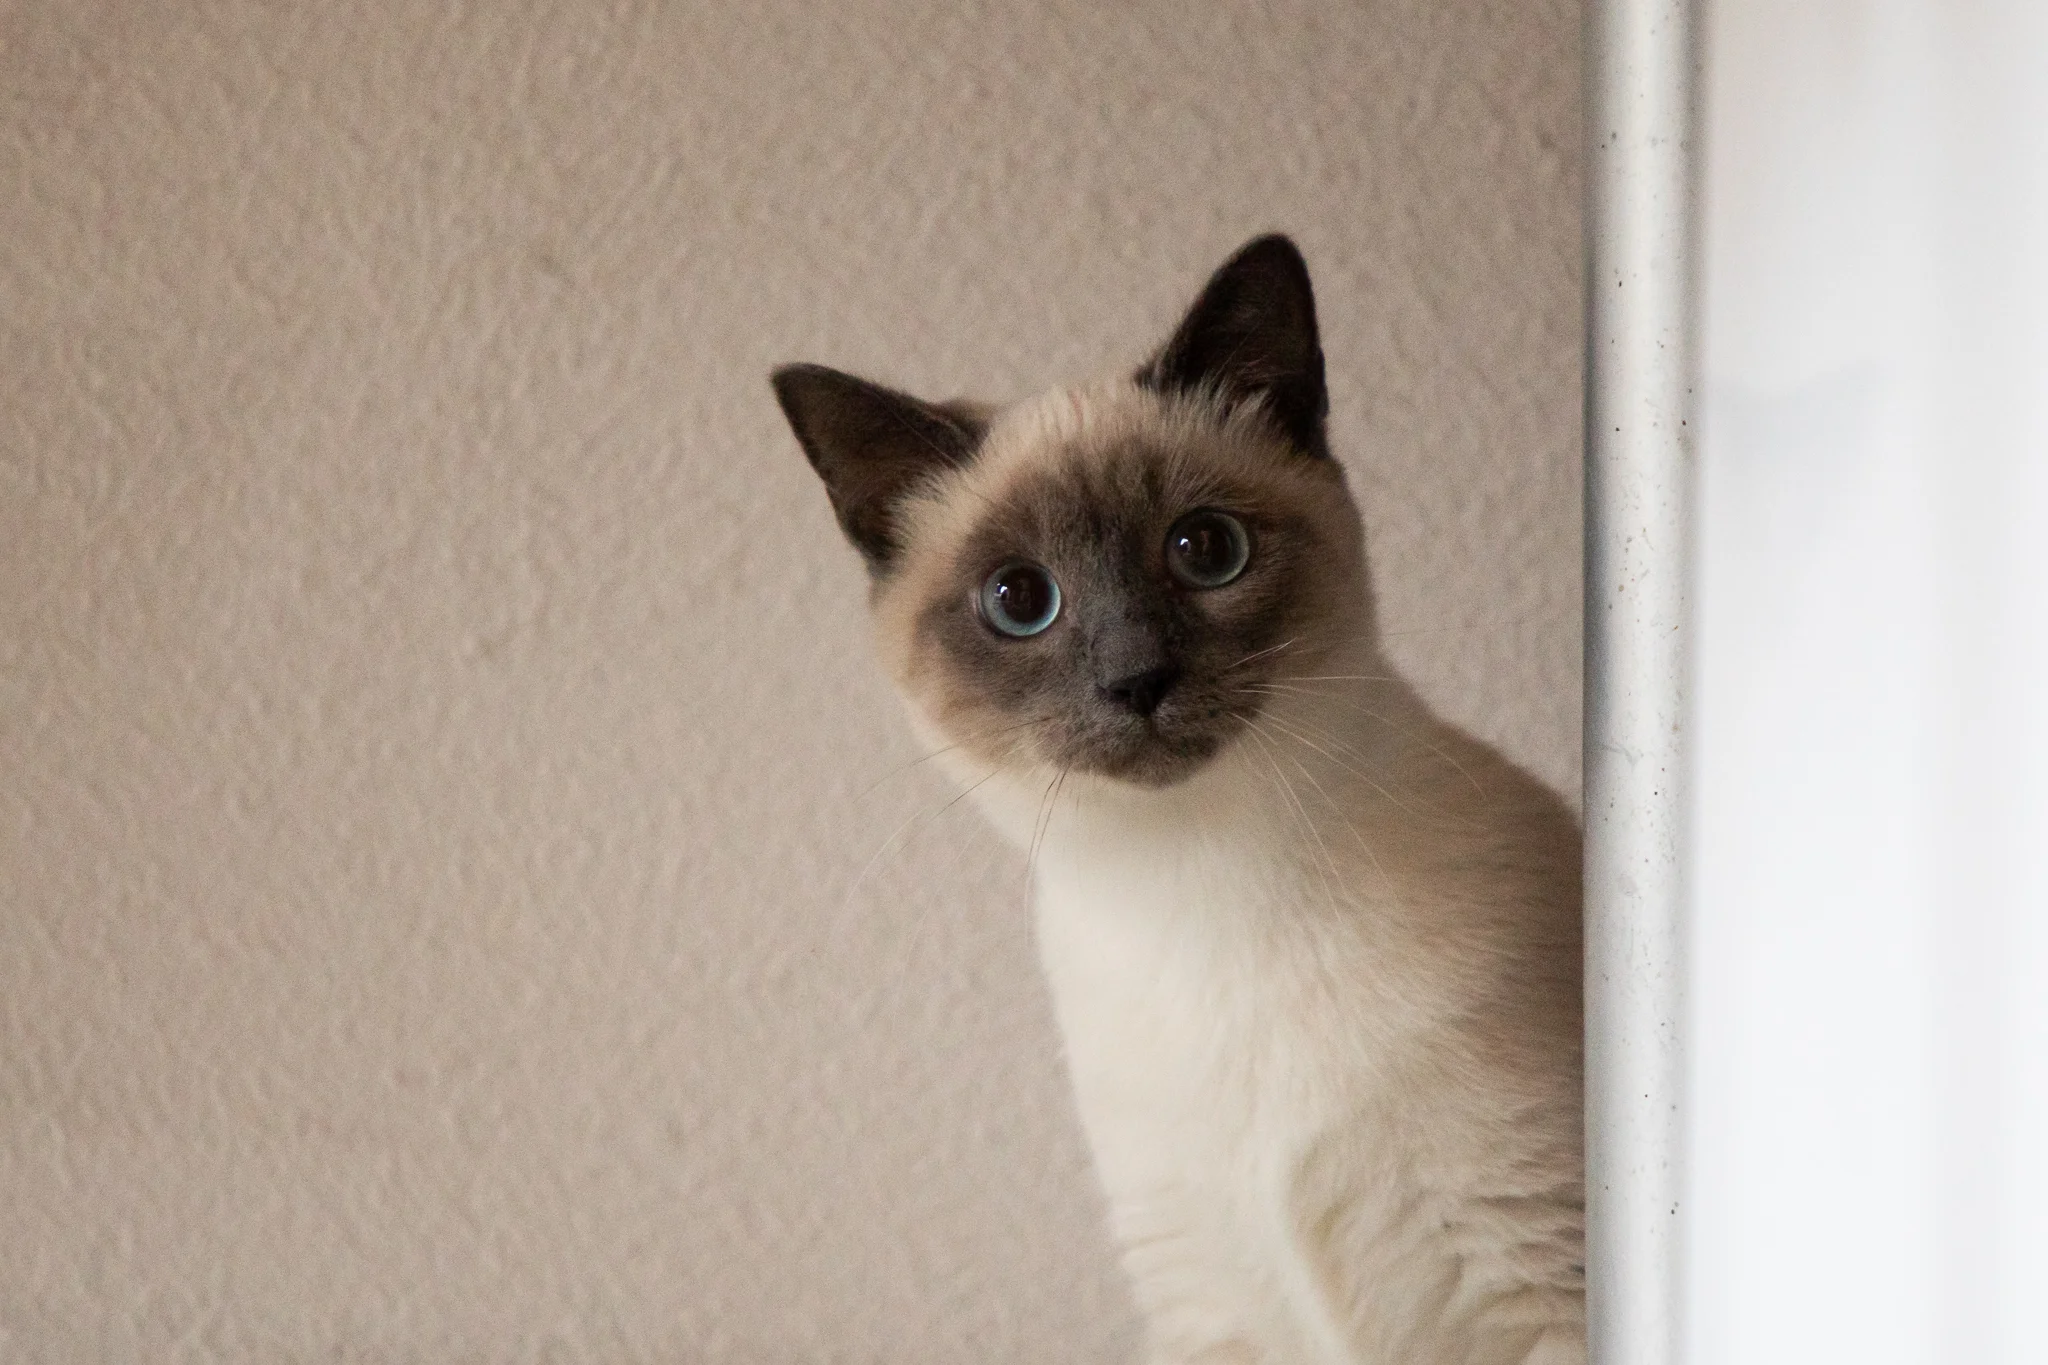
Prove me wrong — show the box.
[770,364,983,573]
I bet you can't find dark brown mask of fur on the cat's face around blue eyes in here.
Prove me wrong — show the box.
[913,446,1341,786]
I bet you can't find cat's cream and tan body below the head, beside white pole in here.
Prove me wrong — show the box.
[921,657,1585,1365]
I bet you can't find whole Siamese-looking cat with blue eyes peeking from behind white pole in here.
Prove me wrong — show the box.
[772,235,1585,1365]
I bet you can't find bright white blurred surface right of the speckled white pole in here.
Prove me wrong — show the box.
[1686,0,2048,1365]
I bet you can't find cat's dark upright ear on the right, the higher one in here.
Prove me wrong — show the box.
[1137,235,1329,456]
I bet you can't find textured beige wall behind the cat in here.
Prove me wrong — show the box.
[0,0,1579,1363]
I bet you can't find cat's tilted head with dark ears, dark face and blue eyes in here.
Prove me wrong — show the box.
[774,237,1372,788]
